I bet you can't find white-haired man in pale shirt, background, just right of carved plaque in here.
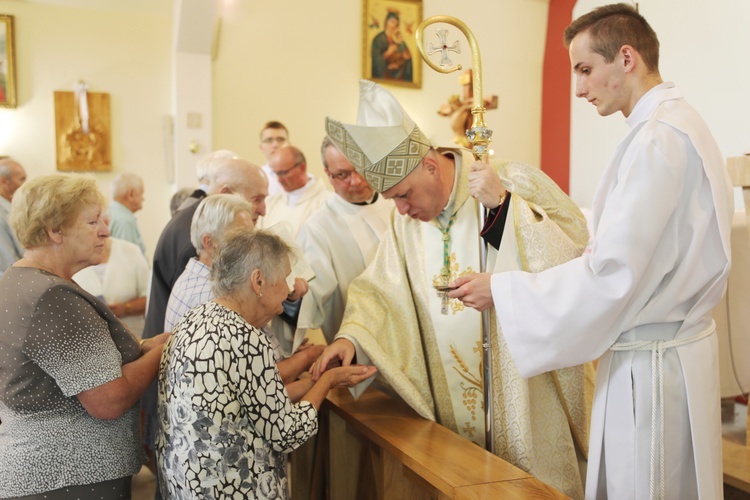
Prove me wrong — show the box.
[109,172,146,255]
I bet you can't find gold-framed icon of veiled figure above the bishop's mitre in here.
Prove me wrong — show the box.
[362,0,422,88]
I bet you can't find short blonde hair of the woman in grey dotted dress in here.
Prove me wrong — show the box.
[10,174,106,248]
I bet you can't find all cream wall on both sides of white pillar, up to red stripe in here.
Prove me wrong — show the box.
[0,0,547,260]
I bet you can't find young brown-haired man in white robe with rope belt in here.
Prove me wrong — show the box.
[451,4,733,500]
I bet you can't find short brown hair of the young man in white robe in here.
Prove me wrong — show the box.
[563,3,659,73]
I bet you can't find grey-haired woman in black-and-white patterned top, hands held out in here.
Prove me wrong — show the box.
[156,228,375,498]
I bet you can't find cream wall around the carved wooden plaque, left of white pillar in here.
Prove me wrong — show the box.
[0,1,172,262]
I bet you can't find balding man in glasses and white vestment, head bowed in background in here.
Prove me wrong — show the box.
[260,146,331,238]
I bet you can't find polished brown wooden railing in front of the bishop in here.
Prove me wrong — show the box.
[322,388,566,500]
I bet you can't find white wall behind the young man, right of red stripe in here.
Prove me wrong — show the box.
[570,0,750,206]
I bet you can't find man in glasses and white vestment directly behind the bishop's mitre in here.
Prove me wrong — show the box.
[295,136,393,345]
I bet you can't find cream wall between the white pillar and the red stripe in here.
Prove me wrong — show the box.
[214,0,547,178]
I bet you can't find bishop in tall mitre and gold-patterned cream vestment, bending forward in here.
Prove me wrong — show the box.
[313,81,593,498]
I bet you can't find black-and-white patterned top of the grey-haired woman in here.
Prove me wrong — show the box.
[156,302,318,499]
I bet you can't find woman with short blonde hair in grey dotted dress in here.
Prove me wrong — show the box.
[0,174,166,499]
